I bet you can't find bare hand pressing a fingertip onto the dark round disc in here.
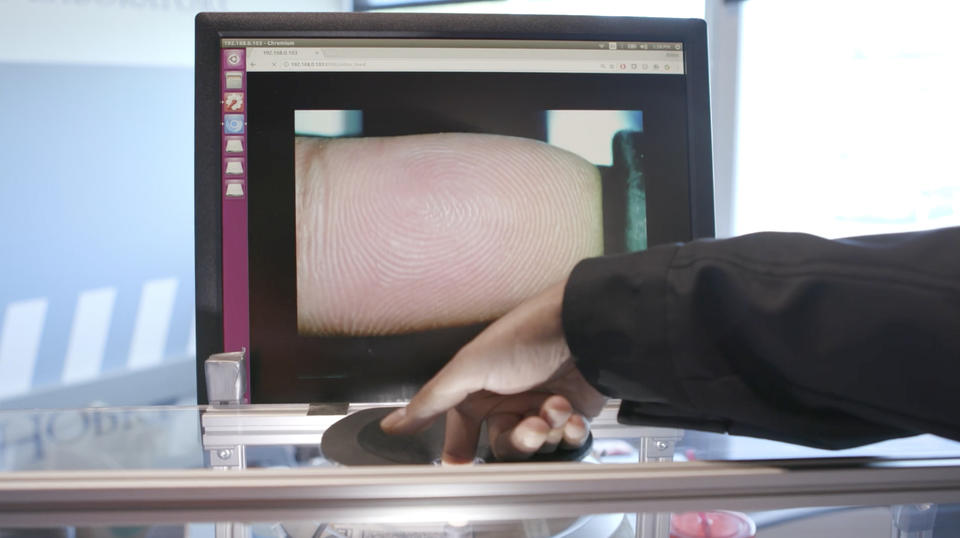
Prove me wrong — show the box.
[381,282,606,463]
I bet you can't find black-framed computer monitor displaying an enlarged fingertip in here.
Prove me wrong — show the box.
[195,13,713,403]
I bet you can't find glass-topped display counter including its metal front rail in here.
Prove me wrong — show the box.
[0,402,960,538]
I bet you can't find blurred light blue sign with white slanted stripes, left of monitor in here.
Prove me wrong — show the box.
[0,0,350,408]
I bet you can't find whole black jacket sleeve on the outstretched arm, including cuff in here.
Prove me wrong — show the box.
[563,224,960,448]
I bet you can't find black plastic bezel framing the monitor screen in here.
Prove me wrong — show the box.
[194,13,714,404]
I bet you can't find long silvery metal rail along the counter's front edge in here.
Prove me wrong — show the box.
[0,459,960,526]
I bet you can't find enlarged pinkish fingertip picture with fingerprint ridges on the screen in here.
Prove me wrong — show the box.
[294,111,646,337]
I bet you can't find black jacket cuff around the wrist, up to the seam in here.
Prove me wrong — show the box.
[563,245,687,404]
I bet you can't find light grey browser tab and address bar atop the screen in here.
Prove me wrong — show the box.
[247,47,683,75]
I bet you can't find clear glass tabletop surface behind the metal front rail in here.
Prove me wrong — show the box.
[0,402,960,472]
